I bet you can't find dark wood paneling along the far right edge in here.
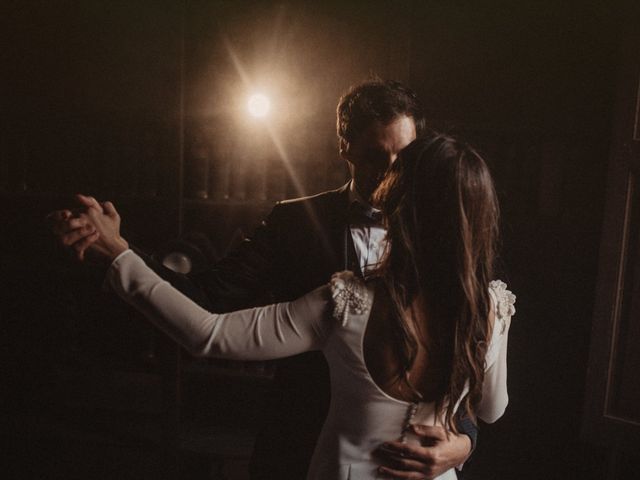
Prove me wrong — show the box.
[583,18,640,460]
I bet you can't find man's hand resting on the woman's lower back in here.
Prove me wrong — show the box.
[376,425,471,480]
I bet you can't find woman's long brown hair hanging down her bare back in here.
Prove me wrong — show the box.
[374,135,499,432]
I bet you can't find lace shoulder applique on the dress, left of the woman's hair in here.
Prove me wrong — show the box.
[330,271,369,327]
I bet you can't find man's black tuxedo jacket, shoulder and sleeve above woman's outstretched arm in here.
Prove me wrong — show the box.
[191,181,358,311]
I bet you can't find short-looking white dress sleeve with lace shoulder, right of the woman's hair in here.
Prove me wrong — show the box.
[477,280,516,423]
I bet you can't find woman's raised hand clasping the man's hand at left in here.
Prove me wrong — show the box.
[73,195,129,263]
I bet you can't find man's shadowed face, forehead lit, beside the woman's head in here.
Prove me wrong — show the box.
[341,115,416,200]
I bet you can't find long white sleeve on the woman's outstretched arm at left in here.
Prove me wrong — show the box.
[107,250,334,360]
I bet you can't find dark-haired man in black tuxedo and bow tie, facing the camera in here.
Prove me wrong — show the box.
[53,81,476,479]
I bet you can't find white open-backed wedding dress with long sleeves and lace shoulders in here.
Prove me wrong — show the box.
[107,250,515,480]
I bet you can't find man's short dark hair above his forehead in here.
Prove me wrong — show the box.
[337,79,425,143]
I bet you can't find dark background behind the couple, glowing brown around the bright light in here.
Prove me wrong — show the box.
[0,0,638,479]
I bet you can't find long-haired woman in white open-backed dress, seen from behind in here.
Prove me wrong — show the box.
[79,135,515,480]
